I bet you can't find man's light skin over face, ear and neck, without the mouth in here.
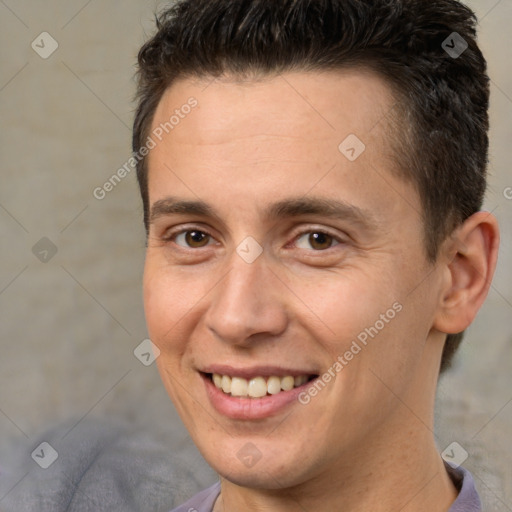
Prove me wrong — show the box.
[144,70,498,512]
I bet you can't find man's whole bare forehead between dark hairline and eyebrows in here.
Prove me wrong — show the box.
[144,70,411,229]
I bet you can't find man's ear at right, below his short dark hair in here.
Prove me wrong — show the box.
[433,212,499,334]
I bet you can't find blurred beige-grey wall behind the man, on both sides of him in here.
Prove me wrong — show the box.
[0,0,512,511]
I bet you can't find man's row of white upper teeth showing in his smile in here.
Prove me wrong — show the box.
[213,373,309,398]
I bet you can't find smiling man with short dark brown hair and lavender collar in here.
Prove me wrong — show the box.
[133,0,499,512]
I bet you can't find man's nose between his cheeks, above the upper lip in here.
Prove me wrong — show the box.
[205,252,288,346]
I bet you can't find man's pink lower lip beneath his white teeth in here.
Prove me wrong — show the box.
[201,374,314,420]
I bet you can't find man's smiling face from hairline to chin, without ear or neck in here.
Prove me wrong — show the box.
[144,71,442,488]
